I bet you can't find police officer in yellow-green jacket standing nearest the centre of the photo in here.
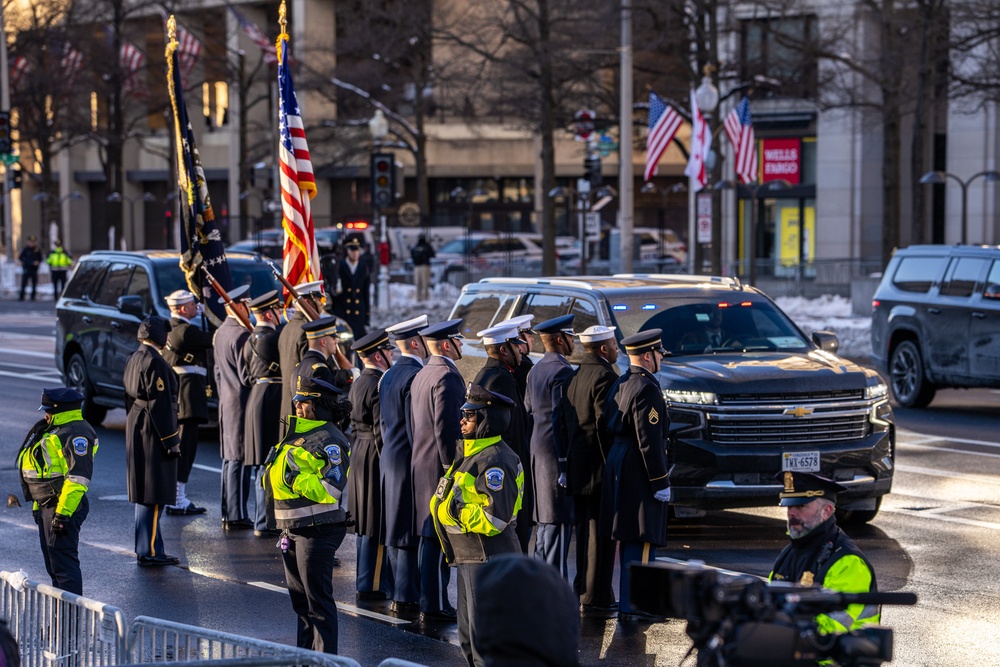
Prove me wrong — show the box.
[430,384,524,665]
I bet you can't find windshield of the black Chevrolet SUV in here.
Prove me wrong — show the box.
[610,297,811,356]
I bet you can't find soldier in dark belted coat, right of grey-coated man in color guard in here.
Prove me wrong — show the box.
[243,290,283,537]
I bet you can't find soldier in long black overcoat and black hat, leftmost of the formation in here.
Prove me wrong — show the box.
[123,315,181,566]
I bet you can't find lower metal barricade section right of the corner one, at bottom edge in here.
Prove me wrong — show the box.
[123,616,360,667]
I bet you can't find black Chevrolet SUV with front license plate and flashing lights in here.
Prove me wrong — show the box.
[451,275,895,522]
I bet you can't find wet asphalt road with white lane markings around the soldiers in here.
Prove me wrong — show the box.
[0,301,1000,666]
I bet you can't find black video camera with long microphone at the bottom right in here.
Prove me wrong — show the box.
[629,562,917,667]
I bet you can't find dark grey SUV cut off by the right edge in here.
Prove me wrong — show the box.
[871,245,1000,408]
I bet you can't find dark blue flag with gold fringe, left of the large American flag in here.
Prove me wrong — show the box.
[166,18,233,321]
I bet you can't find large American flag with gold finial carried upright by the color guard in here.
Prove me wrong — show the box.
[278,35,321,300]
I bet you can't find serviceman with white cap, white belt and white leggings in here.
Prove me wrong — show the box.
[163,290,212,516]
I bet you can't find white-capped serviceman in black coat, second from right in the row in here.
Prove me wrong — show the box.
[563,325,618,614]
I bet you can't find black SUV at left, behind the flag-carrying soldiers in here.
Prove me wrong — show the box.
[56,251,280,426]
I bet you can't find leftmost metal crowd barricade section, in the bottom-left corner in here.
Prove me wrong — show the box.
[0,572,126,667]
